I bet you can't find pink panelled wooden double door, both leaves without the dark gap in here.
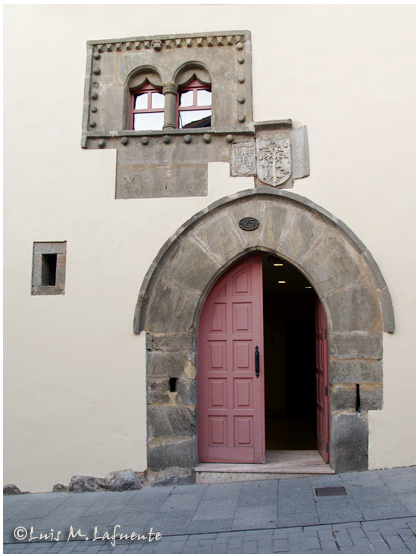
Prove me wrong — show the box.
[198,253,328,463]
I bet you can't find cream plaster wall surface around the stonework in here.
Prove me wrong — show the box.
[4,5,415,492]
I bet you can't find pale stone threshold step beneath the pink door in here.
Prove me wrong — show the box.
[195,450,334,483]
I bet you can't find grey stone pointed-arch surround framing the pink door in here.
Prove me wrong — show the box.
[134,187,394,475]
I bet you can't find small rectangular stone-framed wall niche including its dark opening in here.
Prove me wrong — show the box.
[31,241,67,295]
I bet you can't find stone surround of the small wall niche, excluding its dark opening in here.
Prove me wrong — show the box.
[31,241,67,295]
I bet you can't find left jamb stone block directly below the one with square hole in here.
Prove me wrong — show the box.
[147,405,196,438]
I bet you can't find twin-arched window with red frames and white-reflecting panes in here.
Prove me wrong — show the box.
[129,71,212,131]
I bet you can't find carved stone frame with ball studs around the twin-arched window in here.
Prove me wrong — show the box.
[81,30,253,149]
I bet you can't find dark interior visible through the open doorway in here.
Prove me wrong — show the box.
[263,255,317,450]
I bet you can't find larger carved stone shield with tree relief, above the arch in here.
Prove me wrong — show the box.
[257,137,291,187]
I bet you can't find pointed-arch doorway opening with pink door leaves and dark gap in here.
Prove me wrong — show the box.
[198,252,329,463]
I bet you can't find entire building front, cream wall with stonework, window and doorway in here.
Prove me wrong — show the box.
[4,5,415,492]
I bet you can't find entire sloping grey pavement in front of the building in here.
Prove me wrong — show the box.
[4,467,416,554]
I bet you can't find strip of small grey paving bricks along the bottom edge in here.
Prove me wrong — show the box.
[4,518,416,554]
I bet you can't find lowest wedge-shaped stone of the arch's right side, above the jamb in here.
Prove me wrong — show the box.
[326,285,380,332]
